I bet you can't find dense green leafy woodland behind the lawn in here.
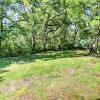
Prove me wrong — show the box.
[0,0,100,56]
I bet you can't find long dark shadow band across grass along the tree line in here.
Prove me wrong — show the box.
[0,51,88,68]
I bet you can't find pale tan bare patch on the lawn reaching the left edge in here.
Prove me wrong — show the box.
[0,75,48,94]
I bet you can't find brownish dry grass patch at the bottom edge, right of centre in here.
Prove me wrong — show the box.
[46,88,84,100]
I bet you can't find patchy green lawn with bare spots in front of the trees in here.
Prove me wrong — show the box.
[0,51,100,100]
